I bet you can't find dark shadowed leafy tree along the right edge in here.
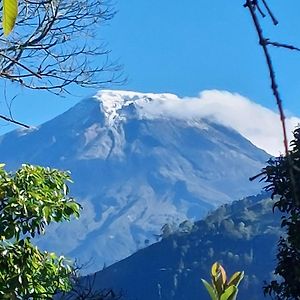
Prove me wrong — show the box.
[255,128,300,300]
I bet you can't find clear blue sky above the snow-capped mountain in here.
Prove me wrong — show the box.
[0,0,300,132]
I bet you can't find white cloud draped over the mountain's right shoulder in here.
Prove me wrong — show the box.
[141,90,300,155]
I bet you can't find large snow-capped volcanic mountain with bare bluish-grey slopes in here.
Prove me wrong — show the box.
[0,91,269,272]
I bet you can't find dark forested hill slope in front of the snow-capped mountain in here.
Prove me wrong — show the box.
[86,195,281,300]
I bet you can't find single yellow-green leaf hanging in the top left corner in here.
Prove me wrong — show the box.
[2,0,18,35]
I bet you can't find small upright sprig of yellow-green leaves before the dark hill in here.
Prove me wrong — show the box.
[201,262,244,300]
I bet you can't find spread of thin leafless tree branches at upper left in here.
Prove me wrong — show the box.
[0,0,123,94]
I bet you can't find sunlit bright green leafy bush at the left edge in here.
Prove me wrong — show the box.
[0,165,81,299]
